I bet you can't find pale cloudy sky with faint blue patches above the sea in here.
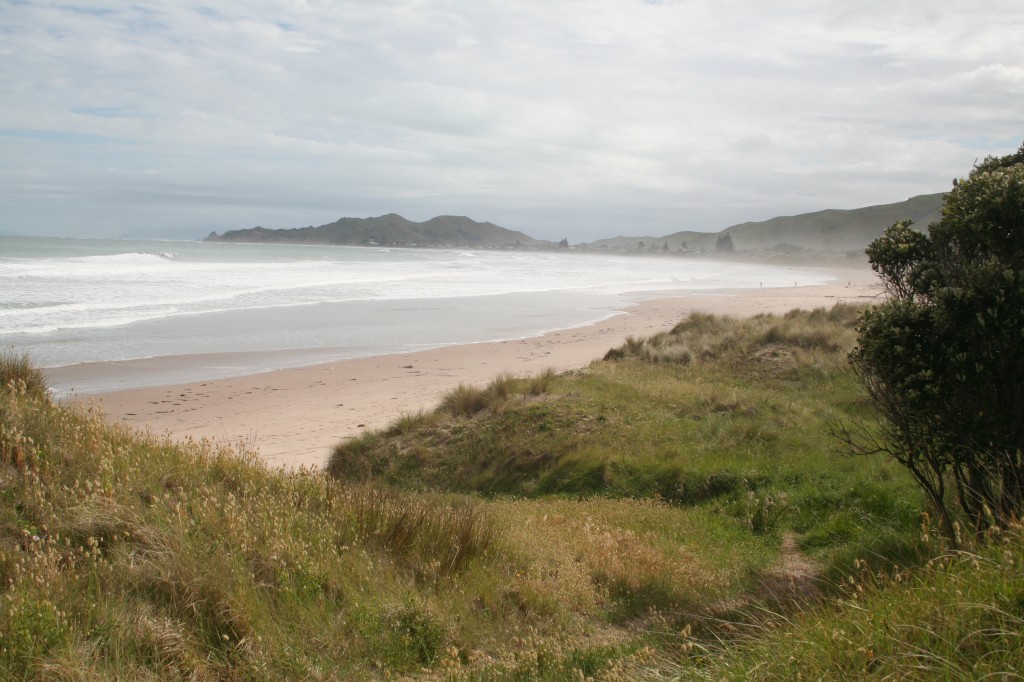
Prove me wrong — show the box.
[0,0,1024,243]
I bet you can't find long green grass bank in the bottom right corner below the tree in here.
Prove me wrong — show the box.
[631,527,1024,681]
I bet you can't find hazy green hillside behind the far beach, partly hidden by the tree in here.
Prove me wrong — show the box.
[587,193,944,252]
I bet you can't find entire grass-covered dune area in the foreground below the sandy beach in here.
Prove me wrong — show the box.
[0,309,1024,680]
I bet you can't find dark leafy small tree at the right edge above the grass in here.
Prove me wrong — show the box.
[843,145,1024,538]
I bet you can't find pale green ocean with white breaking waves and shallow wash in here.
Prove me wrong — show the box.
[0,237,831,394]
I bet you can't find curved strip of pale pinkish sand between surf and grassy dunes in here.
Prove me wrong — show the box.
[55,267,881,467]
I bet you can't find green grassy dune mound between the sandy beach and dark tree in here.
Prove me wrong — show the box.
[328,305,922,563]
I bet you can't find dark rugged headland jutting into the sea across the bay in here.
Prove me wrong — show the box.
[206,213,555,249]
